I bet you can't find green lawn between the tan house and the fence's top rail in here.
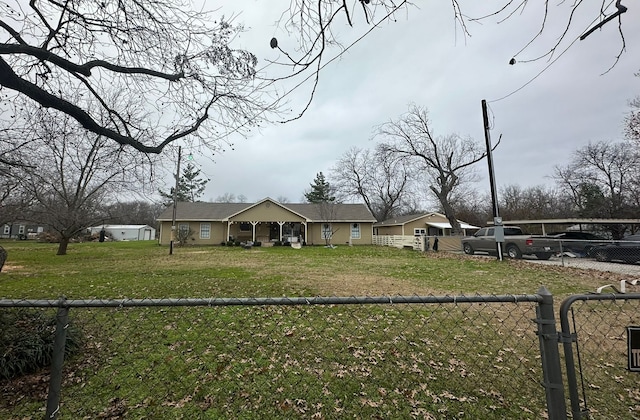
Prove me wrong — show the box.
[0,241,628,299]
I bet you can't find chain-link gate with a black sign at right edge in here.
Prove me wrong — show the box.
[560,293,640,419]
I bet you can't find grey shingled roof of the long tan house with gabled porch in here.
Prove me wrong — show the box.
[157,198,376,222]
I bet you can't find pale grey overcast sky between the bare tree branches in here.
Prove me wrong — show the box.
[166,0,640,202]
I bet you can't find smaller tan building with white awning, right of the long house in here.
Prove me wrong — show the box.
[373,212,480,236]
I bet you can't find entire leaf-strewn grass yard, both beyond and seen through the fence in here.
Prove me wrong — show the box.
[0,241,640,418]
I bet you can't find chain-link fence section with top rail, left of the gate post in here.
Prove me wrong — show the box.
[0,294,565,418]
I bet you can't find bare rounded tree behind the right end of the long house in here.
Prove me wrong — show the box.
[330,147,412,221]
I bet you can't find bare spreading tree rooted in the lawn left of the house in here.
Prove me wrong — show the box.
[23,109,152,255]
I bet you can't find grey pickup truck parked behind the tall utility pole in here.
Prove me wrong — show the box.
[462,226,559,260]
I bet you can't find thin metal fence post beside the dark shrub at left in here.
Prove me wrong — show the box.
[45,297,69,419]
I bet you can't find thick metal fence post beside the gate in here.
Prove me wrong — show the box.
[536,286,567,420]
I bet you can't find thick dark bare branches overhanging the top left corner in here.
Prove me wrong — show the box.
[0,0,271,153]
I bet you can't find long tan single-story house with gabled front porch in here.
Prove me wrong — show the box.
[157,197,376,245]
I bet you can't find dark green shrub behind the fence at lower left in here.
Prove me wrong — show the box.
[0,308,82,379]
